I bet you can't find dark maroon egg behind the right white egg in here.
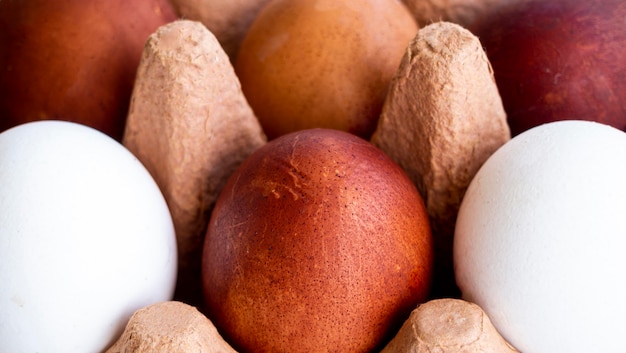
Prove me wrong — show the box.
[468,0,626,136]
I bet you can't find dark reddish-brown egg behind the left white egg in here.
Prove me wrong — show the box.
[0,0,176,139]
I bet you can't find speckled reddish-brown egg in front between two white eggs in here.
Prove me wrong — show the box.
[202,129,433,353]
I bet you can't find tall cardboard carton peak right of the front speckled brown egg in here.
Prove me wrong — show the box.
[372,22,511,296]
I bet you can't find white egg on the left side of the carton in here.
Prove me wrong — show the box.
[0,121,177,353]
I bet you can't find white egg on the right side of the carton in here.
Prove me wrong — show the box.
[454,120,626,353]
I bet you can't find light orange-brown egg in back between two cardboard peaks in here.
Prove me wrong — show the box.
[235,0,417,139]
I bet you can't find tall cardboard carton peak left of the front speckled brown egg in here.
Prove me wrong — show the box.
[123,20,266,305]
